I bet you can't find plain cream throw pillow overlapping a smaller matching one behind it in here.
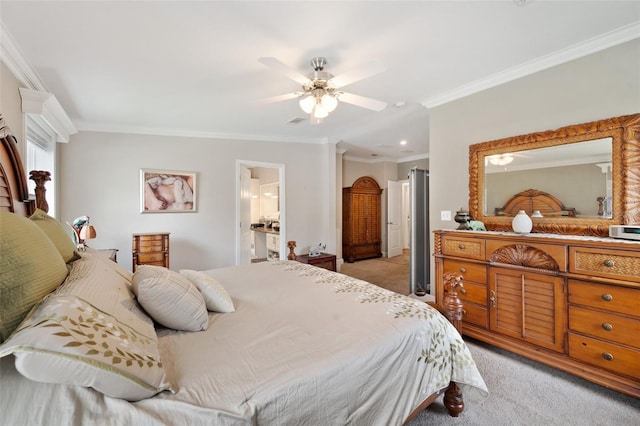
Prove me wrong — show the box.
[133,265,209,331]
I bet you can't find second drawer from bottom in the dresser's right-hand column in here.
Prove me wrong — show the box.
[569,306,640,350]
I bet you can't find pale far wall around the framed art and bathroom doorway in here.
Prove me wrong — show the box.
[60,132,336,270]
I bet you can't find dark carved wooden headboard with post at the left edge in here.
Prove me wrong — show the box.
[0,115,50,216]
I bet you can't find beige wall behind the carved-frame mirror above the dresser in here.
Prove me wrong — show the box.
[429,39,640,288]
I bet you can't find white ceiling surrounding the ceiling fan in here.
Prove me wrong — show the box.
[0,0,640,161]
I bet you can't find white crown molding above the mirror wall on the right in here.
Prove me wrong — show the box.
[421,21,640,108]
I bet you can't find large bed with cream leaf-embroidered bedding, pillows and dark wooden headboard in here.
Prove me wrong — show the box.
[0,120,487,425]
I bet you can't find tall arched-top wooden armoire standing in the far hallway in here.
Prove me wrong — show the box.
[342,176,382,262]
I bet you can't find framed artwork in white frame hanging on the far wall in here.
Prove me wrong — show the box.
[140,169,197,213]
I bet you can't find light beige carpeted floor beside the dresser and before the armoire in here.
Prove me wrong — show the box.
[341,252,640,426]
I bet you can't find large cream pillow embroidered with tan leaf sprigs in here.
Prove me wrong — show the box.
[0,258,170,401]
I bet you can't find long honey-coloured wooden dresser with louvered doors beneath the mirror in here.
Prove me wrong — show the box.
[434,231,640,398]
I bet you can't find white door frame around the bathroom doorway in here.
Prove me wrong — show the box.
[235,160,287,265]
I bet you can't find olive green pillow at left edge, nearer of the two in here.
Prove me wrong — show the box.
[0,212,68,342]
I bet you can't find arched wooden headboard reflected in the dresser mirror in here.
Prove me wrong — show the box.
[495,189,576,217]
